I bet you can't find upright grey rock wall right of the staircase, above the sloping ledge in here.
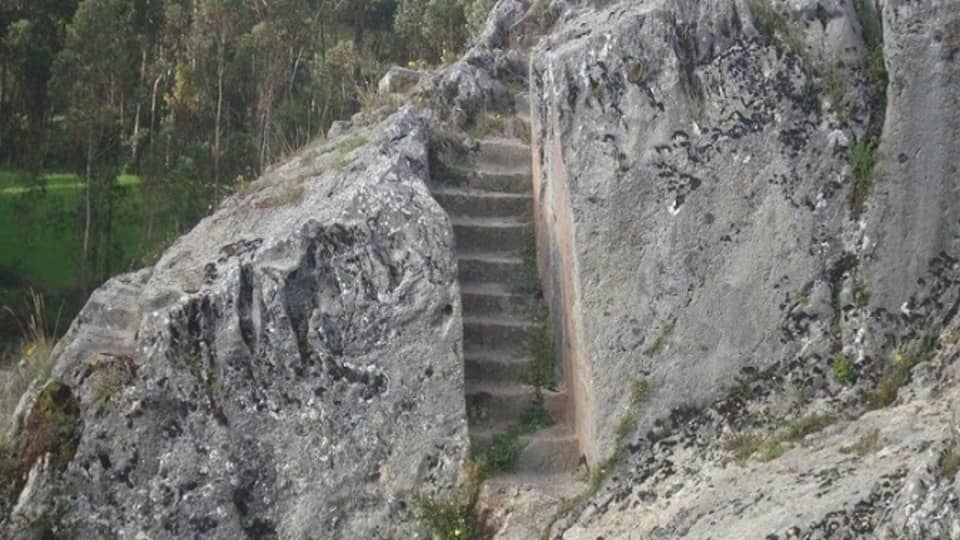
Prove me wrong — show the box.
[531,1,958,463]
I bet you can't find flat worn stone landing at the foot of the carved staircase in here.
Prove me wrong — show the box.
[470,424,580,474]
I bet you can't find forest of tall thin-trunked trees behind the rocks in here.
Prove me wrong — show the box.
[0,0,493,338]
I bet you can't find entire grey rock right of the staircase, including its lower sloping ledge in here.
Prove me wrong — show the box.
[531,0,960,539]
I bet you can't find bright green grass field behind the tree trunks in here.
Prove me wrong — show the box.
[0,170,163,295]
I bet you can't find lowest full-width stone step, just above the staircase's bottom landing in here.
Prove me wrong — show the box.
[466,379,567,431]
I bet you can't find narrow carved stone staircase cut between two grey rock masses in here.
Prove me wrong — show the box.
[433,96,580,481]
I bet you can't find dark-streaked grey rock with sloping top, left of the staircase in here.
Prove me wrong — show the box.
[2,109,468,538]
